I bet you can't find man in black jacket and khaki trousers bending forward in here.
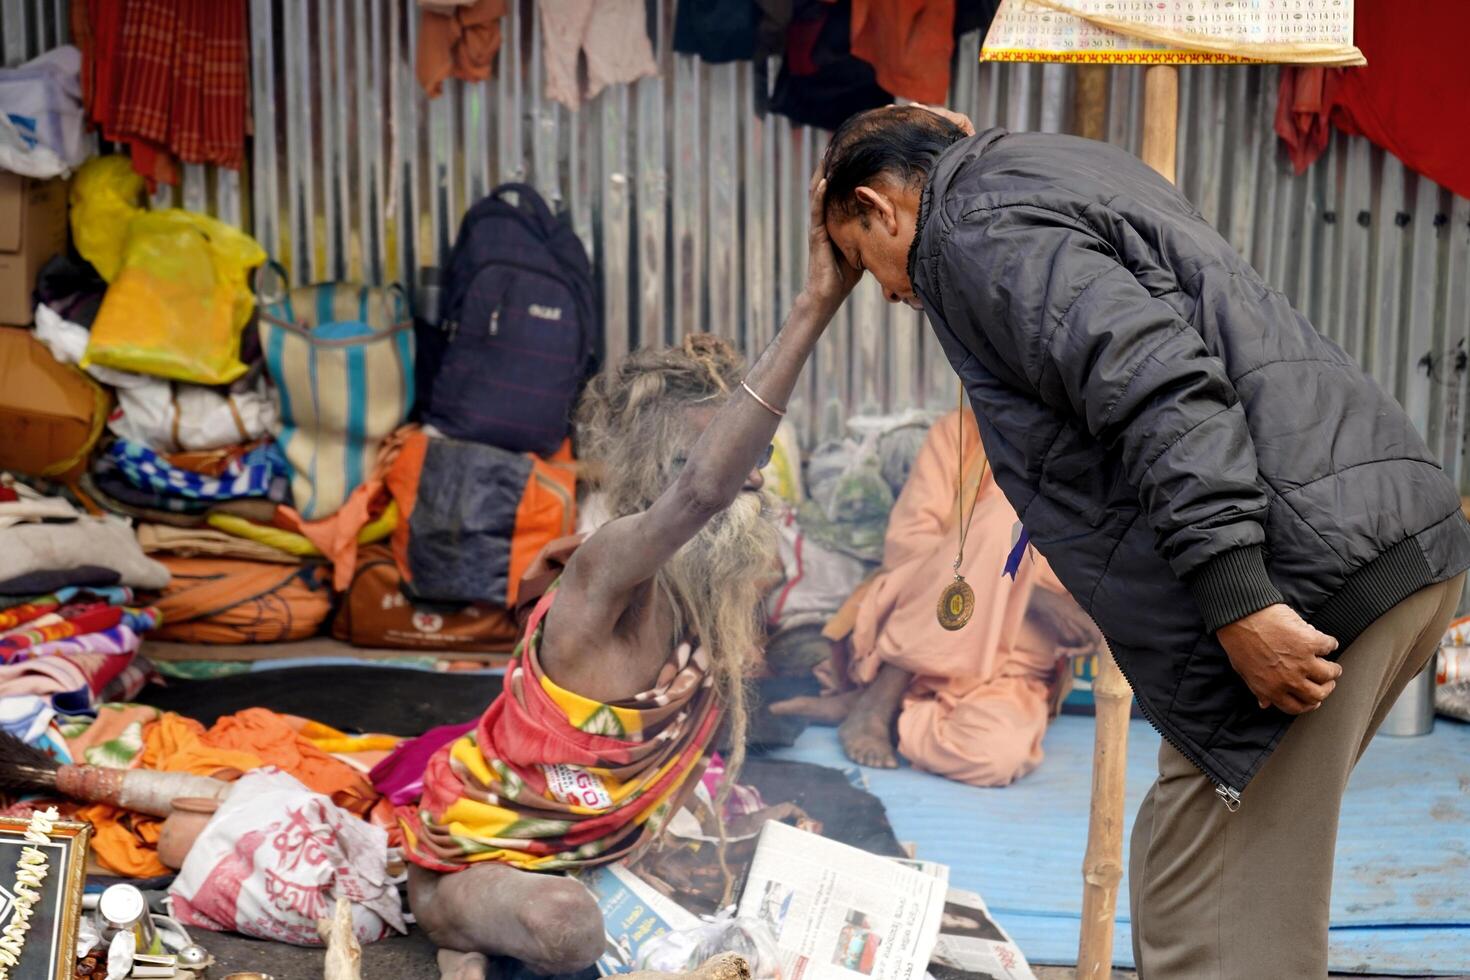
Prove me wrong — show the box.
[823,107,1470,980]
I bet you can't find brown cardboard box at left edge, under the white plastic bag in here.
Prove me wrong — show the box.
[0,172,66,326]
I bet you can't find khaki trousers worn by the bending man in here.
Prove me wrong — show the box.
[1129,574,1464,980]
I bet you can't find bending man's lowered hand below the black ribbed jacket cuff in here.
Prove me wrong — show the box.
[1216,604,1342,714]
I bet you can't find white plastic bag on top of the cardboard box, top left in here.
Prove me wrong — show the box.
[0,44,90,179]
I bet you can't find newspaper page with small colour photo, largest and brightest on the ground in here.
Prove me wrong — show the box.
[739,823,948,980]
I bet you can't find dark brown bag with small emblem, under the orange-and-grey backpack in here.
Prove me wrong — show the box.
[332,545,519,654]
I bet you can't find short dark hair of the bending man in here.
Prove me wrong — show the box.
[822,106,964,216]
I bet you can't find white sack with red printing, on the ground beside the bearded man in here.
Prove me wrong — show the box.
[169,768,407,946]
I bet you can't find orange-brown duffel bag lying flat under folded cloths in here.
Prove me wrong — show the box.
[148,555,332,644]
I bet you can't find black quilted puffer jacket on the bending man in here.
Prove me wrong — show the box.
[908,129,1470,799]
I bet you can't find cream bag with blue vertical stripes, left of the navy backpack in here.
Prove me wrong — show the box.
[260,282,413,522]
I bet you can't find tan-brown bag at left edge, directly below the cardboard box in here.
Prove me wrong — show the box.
[0,326,110,483]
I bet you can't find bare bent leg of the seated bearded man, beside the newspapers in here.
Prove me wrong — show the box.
[409,861,604,980]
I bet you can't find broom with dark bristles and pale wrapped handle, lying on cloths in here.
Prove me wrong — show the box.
[0,732,231,817]
